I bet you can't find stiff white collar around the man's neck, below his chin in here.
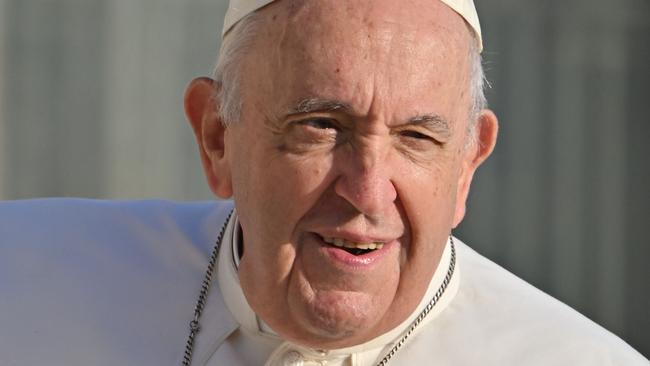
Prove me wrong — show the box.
[217,212,460,366]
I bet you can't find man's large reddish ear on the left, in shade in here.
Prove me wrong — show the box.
[184,77,232,198]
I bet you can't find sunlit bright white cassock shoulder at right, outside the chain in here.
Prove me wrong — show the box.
[388,241,650,366]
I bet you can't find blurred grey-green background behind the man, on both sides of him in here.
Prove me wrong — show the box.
[0,0,650,357]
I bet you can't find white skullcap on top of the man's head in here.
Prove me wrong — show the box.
[221,0,483,51]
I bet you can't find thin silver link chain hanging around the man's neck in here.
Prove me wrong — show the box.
[182,211,456,366]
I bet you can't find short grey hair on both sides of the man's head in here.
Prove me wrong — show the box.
[212,11,487,146]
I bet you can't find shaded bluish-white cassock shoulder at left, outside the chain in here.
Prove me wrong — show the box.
[0,199,236,366]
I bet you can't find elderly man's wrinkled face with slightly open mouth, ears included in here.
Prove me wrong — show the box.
[188,0,496,348]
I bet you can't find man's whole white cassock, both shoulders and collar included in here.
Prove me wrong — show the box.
[0,199,650,366]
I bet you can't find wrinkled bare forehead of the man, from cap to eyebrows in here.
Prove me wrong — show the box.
[238,0,471,122]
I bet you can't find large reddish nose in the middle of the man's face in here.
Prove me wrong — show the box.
[334,142,397,218]
